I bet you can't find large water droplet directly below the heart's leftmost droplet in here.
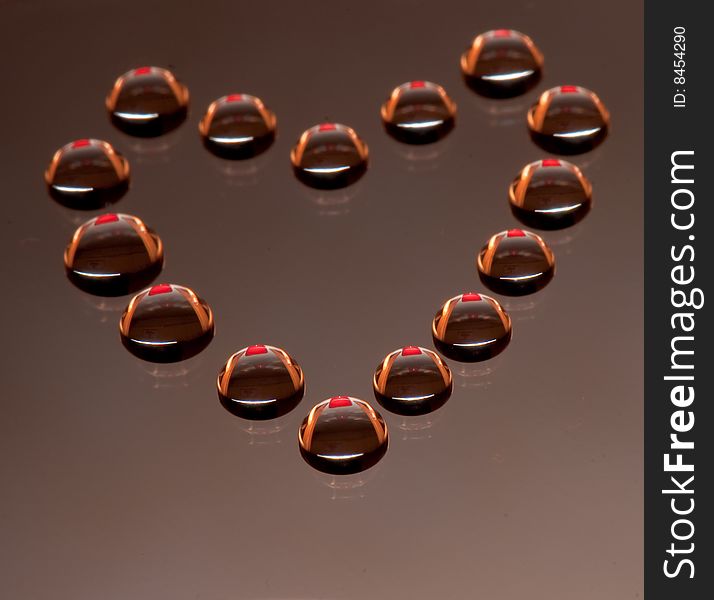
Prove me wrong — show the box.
[64,213,164,296]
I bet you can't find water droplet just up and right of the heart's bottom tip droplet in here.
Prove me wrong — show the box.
[372,346,453,415]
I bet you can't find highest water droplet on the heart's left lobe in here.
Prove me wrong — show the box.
[106,67,188,137]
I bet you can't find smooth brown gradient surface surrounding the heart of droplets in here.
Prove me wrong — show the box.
[0,0,643,600]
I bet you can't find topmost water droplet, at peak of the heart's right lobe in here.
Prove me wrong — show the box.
[461,29,543,98]
